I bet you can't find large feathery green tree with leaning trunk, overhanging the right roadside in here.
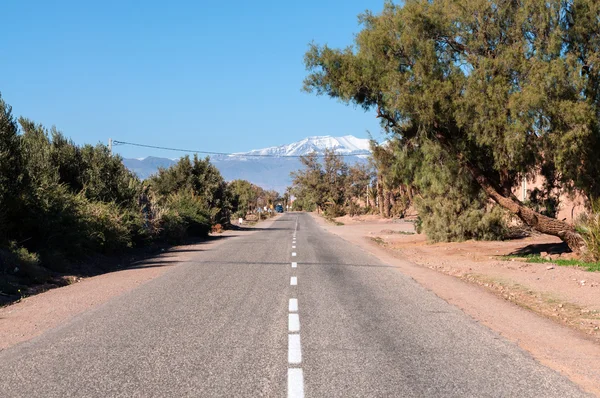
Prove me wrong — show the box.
[305,0,600,251]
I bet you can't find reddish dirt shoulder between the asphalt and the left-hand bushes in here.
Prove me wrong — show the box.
[0,219,275,351]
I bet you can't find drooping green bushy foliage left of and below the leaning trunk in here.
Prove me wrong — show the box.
[373,138,507,242]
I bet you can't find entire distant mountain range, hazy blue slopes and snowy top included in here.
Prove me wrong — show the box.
[123,135,371,193]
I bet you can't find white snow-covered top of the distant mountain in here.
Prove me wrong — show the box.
[239,135,371,156]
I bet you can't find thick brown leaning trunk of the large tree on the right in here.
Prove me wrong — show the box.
[468,165,586,253]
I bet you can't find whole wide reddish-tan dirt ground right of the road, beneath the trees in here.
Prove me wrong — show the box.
[313,211,600,396]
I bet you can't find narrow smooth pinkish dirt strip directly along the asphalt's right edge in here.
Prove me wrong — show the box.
[313,214,600,396]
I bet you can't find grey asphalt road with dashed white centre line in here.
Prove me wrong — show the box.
[0,213,585,398]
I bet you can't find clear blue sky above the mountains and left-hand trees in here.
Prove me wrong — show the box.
[0,0,383,157]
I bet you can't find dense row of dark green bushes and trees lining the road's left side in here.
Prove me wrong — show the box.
[0,93,278,295]
